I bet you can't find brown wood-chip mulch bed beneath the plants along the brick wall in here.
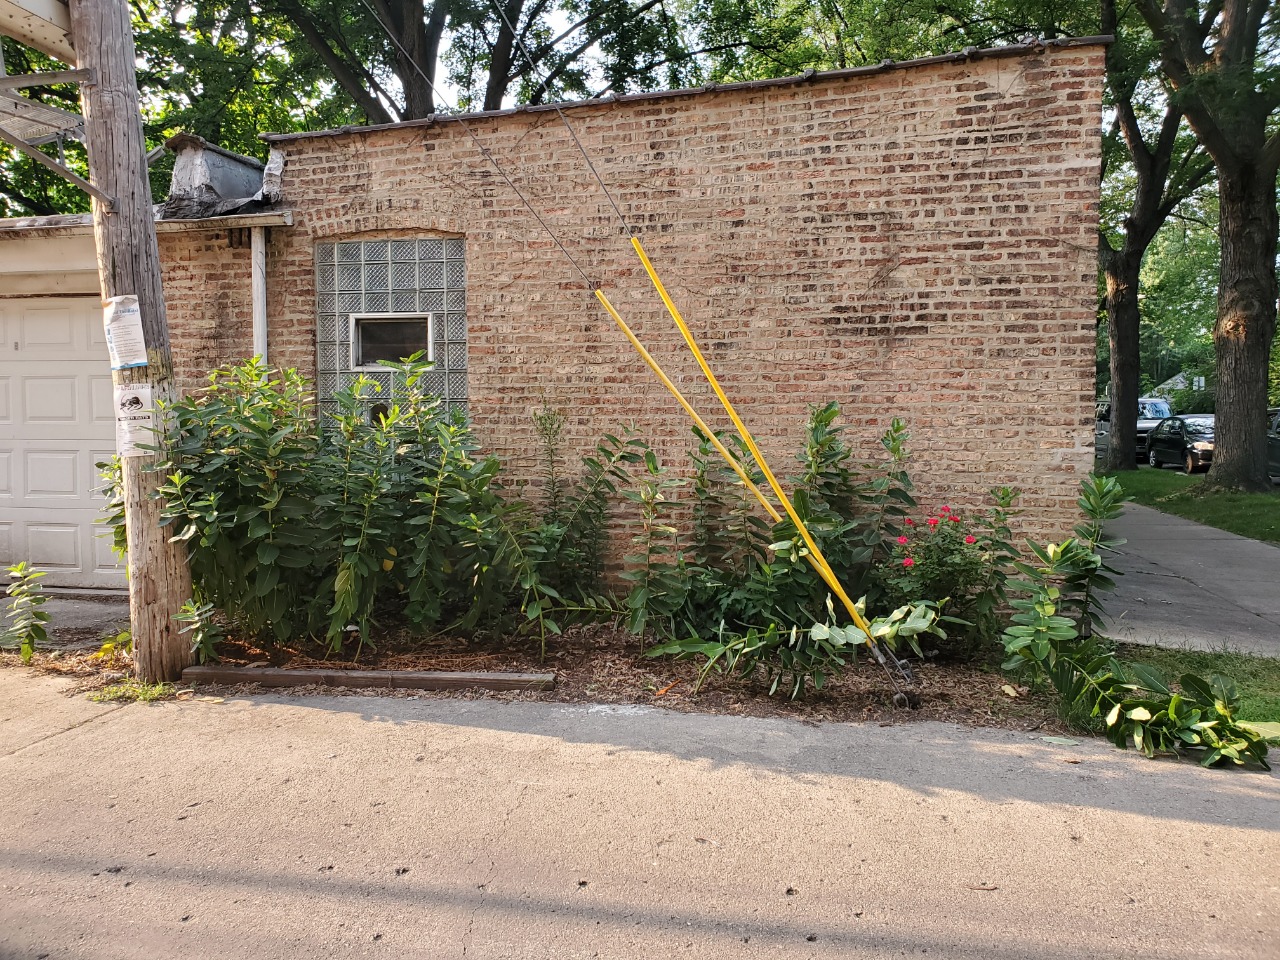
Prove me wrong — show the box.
[0,625,1065,733]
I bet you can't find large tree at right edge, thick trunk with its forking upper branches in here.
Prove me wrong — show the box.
[1138,0,1280,490]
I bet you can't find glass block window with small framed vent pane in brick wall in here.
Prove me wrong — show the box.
[315,237,467,410]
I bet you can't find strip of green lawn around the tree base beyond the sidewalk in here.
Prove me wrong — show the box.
[1111,467,1280,544]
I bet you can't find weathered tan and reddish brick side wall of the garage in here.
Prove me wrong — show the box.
[161,40,1103,545]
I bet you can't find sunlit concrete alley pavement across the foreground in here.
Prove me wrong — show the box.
[0,669,1280,960]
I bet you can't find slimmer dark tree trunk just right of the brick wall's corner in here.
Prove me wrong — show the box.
[1102,246,1144,471]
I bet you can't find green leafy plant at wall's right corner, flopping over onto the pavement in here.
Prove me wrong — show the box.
[1004,477,1270,769]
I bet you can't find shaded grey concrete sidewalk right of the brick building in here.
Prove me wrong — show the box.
[1105,503,1280,657]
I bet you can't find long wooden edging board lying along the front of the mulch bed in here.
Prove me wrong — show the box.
[182,666,556,690]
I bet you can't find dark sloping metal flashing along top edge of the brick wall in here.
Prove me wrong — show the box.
[261,36,1115,143]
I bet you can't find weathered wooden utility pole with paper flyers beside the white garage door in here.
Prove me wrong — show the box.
[70,0,191,682]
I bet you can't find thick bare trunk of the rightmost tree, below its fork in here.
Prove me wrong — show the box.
[1208,164,1277,490]
